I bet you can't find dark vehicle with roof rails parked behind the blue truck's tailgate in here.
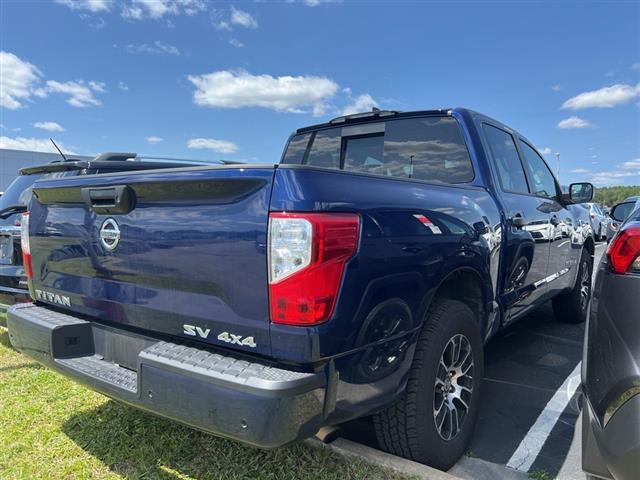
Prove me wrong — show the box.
[0,152,218,312]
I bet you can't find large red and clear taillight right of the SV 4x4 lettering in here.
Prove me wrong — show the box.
[268,213,360,325]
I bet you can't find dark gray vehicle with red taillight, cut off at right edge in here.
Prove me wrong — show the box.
[582,202,640,480]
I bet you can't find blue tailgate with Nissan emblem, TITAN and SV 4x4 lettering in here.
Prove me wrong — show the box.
[29,166,274,355]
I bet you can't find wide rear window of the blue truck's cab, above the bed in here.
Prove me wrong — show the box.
[282,117,474,183]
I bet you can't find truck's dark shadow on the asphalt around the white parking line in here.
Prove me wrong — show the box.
[339,303,584,478]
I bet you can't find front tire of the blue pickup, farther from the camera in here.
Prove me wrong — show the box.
[553,249,593,323]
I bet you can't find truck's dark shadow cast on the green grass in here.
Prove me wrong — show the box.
[62,401,364,480]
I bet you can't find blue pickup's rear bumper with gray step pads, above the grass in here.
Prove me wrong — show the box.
[7,304,327,448]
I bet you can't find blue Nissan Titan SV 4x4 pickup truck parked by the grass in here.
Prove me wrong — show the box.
[8,109,594,469]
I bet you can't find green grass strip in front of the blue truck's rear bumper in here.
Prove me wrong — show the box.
[0,327,404,480]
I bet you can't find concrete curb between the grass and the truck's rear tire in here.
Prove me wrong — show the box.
[304,438,462,480]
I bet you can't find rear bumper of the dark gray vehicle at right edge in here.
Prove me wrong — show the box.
[582,395,640,480]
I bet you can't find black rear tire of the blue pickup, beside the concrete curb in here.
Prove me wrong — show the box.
[373,299,484,470]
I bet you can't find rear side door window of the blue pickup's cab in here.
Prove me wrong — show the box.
[483,124,529,193]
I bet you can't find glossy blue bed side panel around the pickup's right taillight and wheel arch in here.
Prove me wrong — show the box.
[271,166,502,360]
